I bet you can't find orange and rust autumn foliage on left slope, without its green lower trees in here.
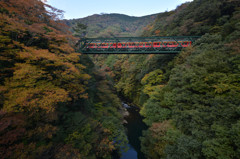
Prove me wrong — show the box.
[0,0,95,158]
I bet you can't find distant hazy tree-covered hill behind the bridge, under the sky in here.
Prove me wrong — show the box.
[64,14,157,38]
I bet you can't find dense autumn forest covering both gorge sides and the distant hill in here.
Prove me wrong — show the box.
[0,0,240,159]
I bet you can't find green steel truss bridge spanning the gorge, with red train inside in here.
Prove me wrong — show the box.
[77,36,200,54]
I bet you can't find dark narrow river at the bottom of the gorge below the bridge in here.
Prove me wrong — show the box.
[121,103,147,159]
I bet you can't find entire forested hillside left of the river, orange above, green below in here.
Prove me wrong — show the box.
[0,0,127,159]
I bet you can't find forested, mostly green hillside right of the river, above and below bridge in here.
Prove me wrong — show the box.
[90,0,240,159]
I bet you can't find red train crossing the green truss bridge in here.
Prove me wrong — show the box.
[87,41,192,49]
